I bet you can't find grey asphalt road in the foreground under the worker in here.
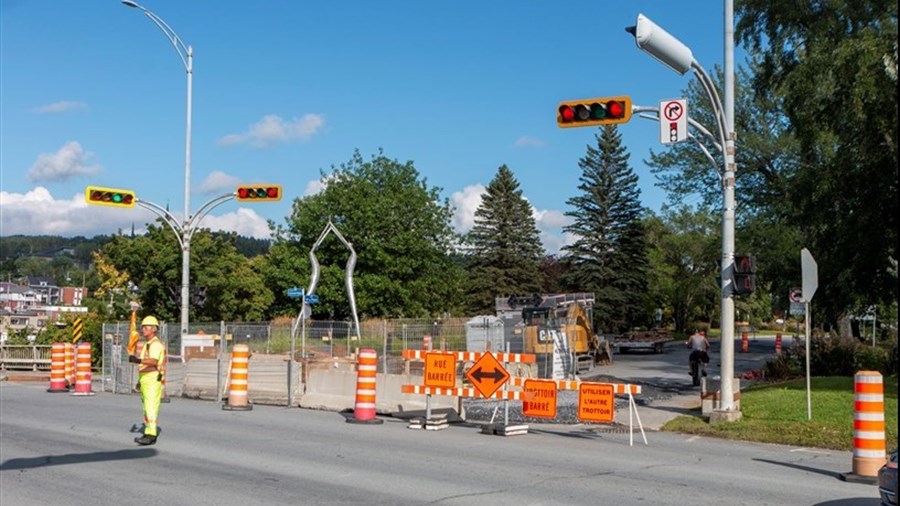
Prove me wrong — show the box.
[0,368,878,506]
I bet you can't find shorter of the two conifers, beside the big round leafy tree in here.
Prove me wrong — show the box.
[467,165,544,313]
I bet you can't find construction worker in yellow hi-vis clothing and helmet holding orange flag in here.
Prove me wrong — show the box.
[128,316,166,446]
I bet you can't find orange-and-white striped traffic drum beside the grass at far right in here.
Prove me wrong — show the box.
[842,371,886,484]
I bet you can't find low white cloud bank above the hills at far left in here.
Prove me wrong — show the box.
[0,186,271,239]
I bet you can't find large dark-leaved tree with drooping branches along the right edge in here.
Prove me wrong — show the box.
[735,0,898,334]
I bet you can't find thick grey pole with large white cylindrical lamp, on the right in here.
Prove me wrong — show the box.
[625,4,741,422]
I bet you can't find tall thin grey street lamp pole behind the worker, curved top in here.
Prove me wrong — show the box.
[122,0,194,337]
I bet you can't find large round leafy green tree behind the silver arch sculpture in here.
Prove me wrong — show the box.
[262,150,463,318]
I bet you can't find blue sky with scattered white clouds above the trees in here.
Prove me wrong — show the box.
[0,0,745,254]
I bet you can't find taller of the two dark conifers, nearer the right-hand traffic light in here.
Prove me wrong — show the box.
[563,126,648,332]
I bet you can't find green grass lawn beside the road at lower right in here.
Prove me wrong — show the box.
[662,376,897,451]
